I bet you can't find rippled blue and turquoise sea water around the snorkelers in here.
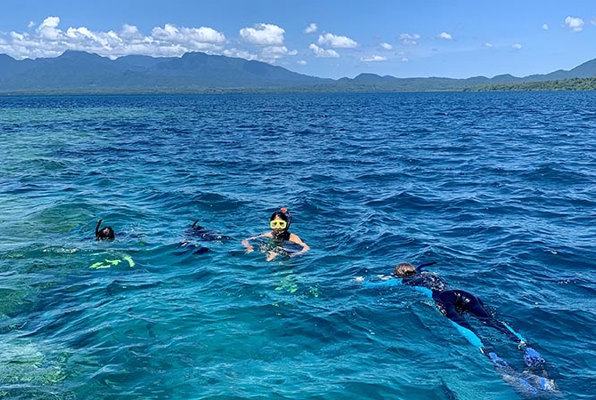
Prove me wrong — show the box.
[0,92,596,400]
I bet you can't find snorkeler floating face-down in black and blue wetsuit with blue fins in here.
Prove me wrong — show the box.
[365,262,556,396]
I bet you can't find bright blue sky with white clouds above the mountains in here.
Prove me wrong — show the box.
[0,0,596,78]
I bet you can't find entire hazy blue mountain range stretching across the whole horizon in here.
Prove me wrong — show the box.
[0,51,596,93]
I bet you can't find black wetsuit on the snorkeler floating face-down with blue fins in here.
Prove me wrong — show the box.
[402,272,519,342]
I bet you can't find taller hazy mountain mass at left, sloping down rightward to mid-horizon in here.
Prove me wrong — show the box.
[0,51,333,92]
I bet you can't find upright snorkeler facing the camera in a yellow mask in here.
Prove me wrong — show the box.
[242,208,310,261]
